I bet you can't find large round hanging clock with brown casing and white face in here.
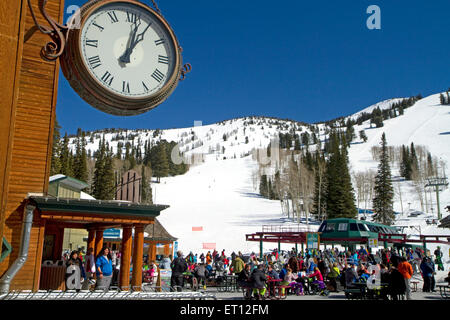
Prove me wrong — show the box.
[60,0,182,115]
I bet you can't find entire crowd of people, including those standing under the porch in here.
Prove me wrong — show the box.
[61,247,450,299]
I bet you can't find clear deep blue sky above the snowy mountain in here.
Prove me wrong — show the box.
[56,0,450,134]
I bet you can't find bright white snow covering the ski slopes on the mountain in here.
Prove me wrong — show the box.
[67,94,450,260]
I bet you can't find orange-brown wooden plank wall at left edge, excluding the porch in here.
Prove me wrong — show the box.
[0,0,64,290]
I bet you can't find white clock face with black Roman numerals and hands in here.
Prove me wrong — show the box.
[80,2,177,98]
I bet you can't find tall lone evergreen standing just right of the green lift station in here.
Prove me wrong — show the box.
[372,133,395,225]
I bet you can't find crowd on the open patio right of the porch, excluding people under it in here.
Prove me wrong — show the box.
[164,247,448,300]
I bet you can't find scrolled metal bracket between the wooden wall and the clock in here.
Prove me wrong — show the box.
[28,0,68,61]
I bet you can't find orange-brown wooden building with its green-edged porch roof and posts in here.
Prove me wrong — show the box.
[0,0,173,291]
